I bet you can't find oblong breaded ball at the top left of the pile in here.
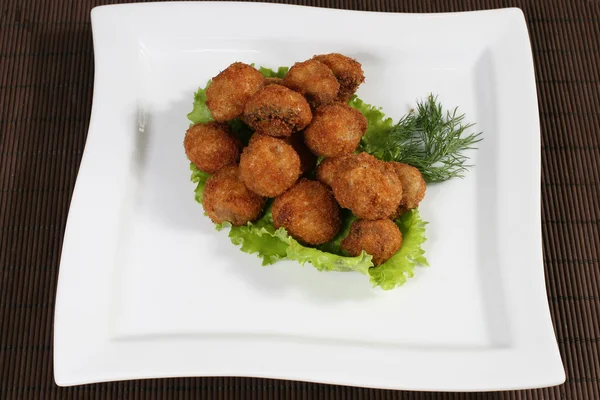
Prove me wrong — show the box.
[206,62,265,122]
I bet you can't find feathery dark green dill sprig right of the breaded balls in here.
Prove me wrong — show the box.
[369,95,481,182]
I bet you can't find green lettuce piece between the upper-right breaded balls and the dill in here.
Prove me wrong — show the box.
[348,95,394,158]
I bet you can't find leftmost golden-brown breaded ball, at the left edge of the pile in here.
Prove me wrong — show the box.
[183,122,242,174]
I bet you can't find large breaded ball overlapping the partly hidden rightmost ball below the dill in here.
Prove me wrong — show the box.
[333,153,402,219]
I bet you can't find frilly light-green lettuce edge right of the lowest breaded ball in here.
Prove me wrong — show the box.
[369,209,429,290]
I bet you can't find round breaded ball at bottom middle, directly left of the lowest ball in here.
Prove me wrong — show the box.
[271,179,341,245]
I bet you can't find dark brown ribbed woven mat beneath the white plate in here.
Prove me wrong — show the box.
[0,0,600,399]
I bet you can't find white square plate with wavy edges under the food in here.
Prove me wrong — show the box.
[54,3,565,391]
